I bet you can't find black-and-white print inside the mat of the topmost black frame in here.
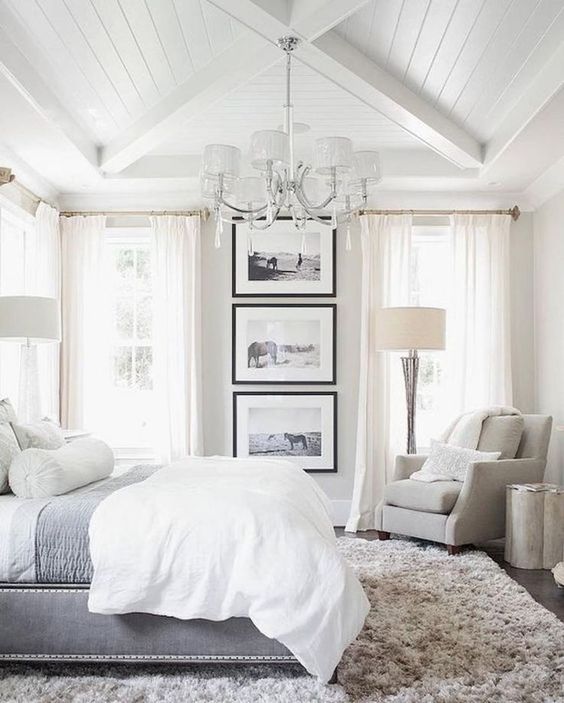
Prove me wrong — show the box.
[248,230,321,281]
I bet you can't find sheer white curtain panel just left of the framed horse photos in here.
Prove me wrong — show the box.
[151,216,203,462]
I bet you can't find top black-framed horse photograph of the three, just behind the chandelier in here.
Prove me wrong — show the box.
[233,217,337,297]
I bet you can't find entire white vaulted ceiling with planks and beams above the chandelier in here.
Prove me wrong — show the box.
[0,0,564,205]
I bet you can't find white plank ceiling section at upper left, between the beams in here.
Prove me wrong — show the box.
[0,0,246,143]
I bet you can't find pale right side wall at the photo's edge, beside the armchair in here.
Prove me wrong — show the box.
[534,191,564,483]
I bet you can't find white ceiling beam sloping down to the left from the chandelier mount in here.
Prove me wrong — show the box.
[100,34,280,173]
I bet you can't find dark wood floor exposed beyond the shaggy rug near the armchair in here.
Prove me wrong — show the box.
[335,527,564,622]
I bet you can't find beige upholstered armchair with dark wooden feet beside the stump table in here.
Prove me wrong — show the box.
[376,415,552,554]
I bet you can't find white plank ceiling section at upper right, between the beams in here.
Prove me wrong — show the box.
[336,0,564,141]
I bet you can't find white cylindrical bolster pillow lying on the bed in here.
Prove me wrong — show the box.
[8,438,114,498]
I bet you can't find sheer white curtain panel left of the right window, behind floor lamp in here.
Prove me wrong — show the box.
[346,215,412,532]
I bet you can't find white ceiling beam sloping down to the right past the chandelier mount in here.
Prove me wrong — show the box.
[211,0,482,168]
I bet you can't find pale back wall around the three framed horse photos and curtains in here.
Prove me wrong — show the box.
[202,213,534,524]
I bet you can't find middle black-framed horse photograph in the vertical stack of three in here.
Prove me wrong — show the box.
[232,303,337,384]
